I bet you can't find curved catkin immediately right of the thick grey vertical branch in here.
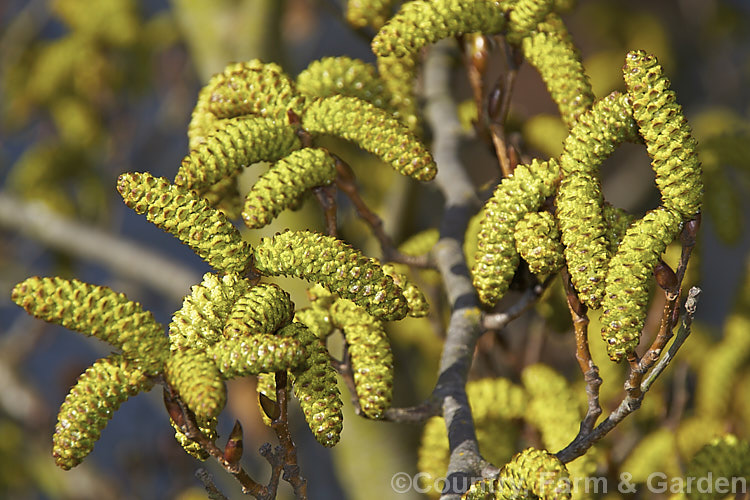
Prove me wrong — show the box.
[472,160,560,305]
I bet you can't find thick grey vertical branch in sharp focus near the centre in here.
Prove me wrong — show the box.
[424,41,486,500]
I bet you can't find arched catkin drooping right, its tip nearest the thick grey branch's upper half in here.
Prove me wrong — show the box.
[302,96,437,181]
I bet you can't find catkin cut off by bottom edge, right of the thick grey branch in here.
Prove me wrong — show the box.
[494,448,571,500]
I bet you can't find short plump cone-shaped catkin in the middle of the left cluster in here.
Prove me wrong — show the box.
[223,283,294,339]
